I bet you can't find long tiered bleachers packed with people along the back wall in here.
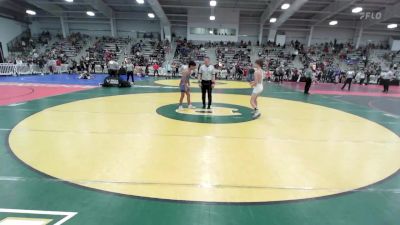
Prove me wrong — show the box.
[4,33,400,82]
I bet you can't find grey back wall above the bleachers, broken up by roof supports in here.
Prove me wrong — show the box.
[22,16,389,47]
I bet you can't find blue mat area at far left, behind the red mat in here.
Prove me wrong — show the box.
[0,74,149,86]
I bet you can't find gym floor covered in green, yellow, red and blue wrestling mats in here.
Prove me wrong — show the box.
[0,75,400,225]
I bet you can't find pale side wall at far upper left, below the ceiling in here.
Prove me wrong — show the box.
[0,17,28,57]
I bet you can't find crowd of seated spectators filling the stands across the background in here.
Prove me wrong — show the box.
[2,32,399,83]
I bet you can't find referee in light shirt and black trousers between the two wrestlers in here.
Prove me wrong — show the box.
[199,57,215,109]
